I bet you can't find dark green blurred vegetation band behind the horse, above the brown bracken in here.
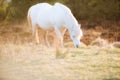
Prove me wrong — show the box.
[0,0,120,21]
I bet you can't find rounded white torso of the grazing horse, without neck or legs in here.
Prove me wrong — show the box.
[28,3,71,29]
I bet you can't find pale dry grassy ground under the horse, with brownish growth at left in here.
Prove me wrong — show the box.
[0,24,120,80]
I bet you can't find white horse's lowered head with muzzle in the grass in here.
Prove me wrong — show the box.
[70,24,83,48]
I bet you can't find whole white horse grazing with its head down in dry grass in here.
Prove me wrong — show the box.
[28,3,82,47]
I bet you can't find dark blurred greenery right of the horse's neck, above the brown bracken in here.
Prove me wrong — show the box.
[67,0,120,20]
